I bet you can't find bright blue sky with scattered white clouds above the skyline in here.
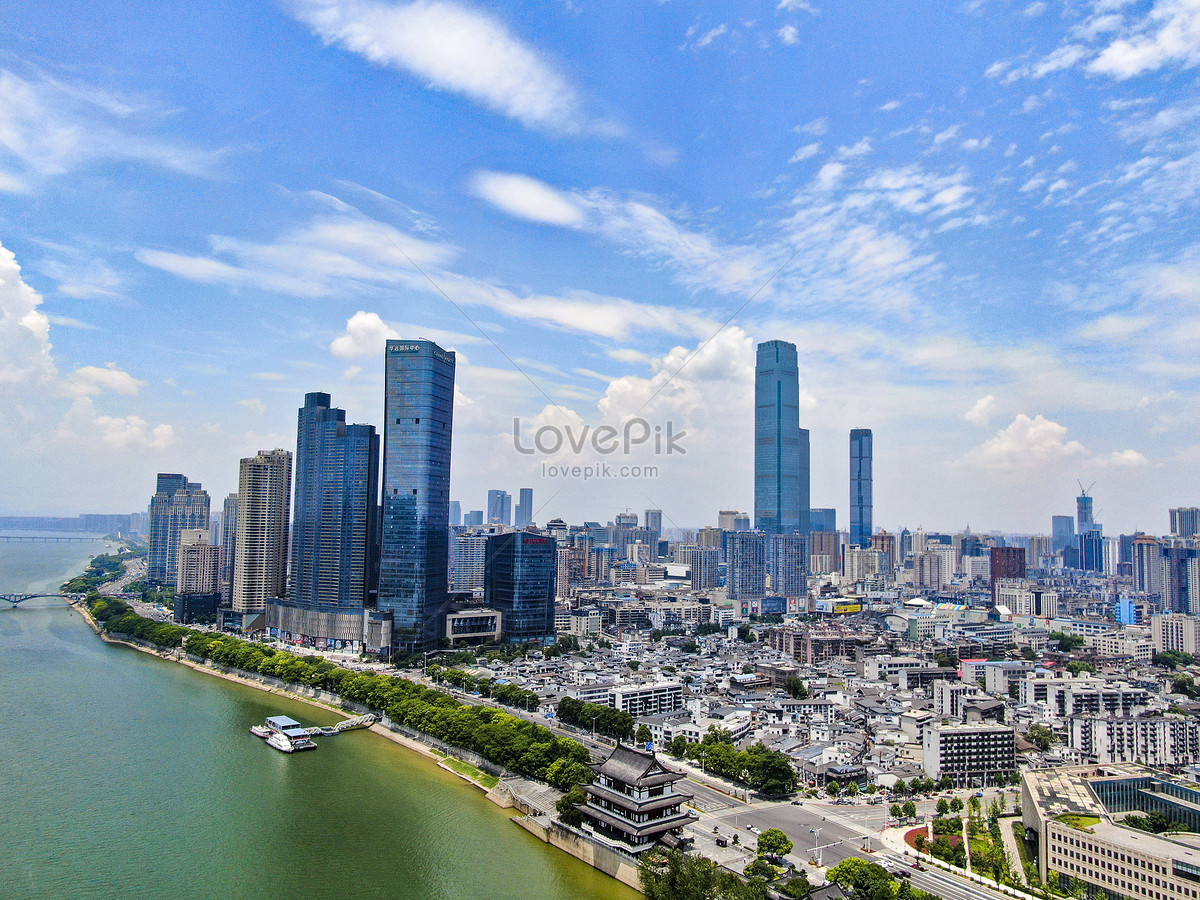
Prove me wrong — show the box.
[0,0,1200,533]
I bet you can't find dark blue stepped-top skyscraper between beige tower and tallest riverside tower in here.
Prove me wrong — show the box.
[290,392,379,608]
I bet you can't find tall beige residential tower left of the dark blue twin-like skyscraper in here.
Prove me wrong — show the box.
[233,450,292,613]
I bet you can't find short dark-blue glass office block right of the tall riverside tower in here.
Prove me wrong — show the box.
[484,532,558,643]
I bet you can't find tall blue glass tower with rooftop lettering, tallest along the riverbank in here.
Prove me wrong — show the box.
[379,341,455,653]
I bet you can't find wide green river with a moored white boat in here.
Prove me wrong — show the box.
[0,544,638,900]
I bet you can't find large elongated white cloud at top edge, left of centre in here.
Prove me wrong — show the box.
[290,0,587,133]
